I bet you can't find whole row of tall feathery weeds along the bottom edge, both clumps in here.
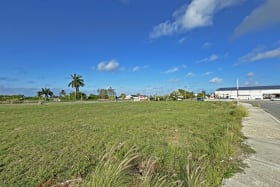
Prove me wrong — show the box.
[82,146,208,187]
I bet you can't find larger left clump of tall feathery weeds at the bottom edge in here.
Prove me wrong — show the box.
[82,144,171,187]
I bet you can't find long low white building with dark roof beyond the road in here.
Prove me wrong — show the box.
[215,85,280,100]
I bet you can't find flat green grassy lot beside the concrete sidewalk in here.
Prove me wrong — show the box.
[0,102,247,186]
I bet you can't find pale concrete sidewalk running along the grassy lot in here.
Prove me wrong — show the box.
[222,103,280,187]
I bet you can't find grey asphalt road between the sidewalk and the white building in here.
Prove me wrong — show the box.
[242,101,280,120]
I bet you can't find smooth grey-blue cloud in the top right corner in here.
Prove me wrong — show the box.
[233,0,280,37]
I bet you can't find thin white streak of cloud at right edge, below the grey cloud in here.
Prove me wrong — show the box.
[239,48,280,62]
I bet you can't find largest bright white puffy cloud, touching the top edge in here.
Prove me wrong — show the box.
[150,0,241,39]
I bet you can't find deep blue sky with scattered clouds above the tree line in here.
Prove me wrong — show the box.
[0,0,280,96]
